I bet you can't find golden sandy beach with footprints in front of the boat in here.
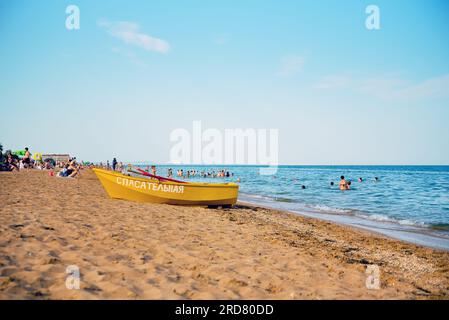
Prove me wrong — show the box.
[0,170,449,299]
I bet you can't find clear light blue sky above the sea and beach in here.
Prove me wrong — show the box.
[0,0,449,164]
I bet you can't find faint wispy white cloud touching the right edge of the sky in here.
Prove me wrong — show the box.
[313,74,449,101]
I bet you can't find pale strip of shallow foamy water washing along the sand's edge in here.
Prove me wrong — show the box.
[239,196,449,251]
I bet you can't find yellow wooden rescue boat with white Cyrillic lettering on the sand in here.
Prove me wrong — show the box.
[92,168,239,206]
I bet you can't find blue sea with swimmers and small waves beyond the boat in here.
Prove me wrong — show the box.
[136,164,449,250]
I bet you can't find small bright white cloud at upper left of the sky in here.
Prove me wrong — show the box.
[98,20,170,53]
